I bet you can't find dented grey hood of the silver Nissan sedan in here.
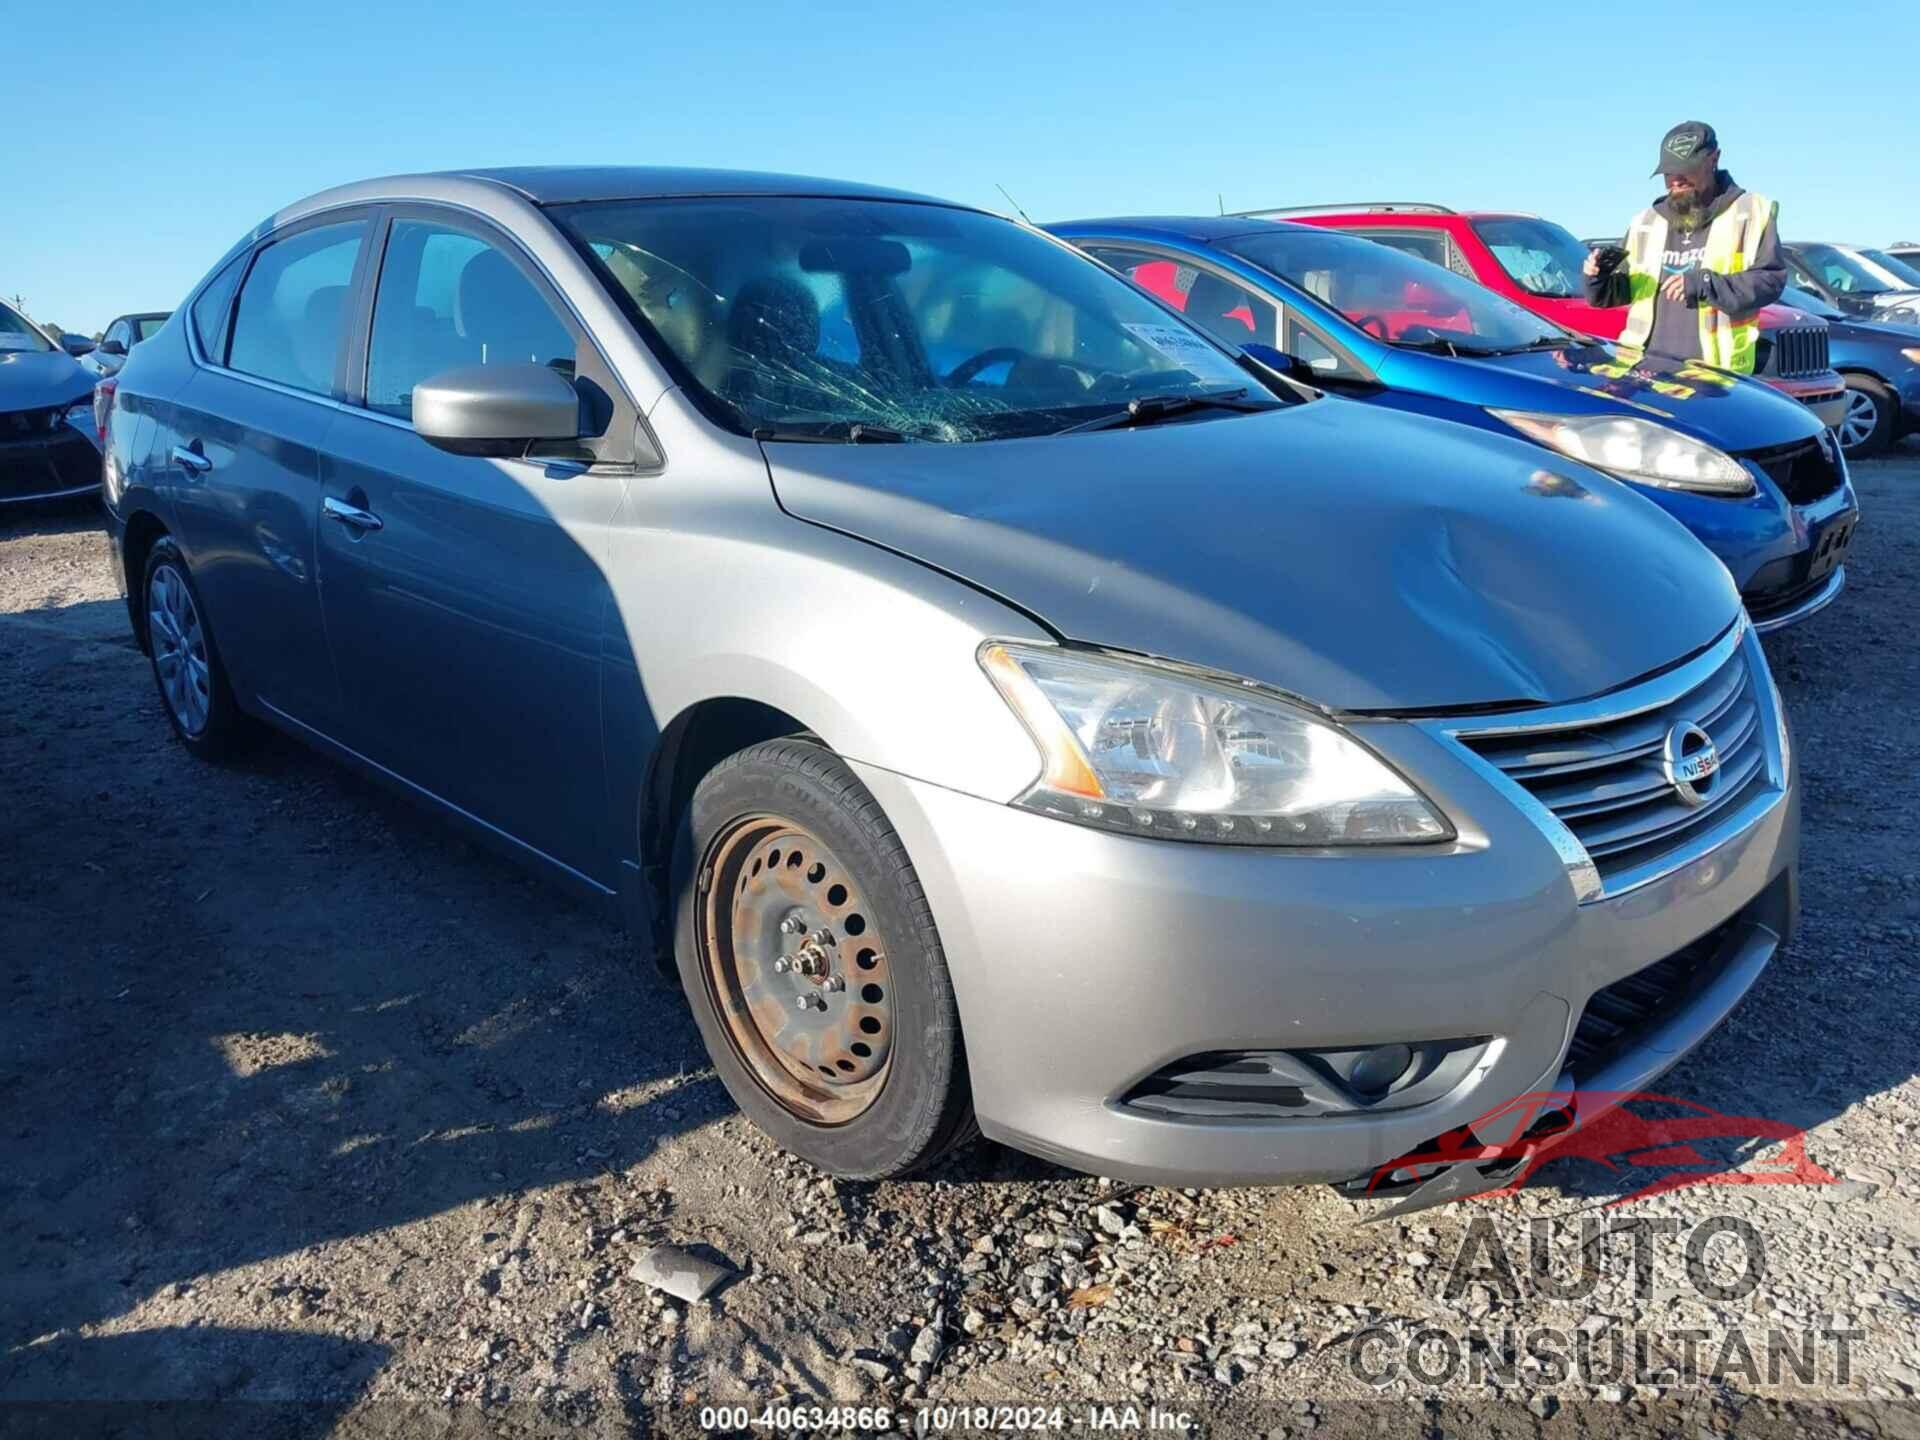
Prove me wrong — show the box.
[764,397,1740,710]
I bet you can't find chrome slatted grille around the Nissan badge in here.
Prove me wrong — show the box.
[1452,637,1772,899]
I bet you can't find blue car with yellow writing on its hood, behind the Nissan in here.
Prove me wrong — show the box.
[1046,215,1859,630]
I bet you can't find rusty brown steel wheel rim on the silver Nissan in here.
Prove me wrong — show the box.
[697,814,893,1125]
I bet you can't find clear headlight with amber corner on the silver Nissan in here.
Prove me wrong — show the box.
[979,643,1453,845]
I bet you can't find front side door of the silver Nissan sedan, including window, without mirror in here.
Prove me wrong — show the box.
[321,207,636,887]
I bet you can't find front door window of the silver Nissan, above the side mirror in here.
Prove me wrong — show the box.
[367,219,574,419]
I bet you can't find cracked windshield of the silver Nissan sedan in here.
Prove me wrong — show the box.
[559,196,1277,442]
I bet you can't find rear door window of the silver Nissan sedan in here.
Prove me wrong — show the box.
[227,221,367,396]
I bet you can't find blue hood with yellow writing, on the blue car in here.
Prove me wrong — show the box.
[1380,344,1820,451]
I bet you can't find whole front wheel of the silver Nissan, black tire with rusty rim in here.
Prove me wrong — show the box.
[674,739,975,1181]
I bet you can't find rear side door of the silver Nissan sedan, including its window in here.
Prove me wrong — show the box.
[156,211,369,733]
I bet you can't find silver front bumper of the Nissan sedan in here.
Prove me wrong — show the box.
[854,639,1799,1185]
